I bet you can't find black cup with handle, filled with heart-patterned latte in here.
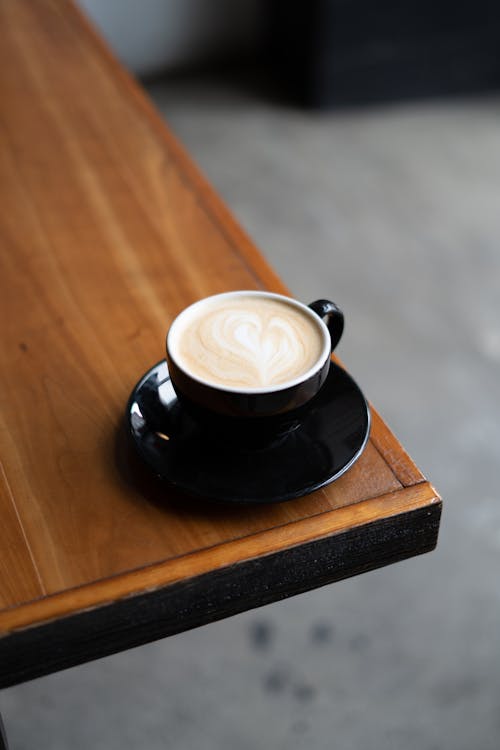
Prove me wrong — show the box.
[166,291,344,423]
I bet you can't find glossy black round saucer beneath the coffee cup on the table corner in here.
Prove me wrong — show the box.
[126,361,370,503]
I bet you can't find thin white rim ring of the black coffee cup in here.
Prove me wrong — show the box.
[166,289,331,396]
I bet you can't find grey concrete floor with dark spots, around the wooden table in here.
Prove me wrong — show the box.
[1,79,500,750]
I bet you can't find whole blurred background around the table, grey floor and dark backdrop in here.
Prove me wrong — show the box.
[2,0,500,750]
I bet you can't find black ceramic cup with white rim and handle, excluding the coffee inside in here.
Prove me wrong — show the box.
[167,291,344,428]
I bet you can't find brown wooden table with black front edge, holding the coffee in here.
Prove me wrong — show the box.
[0,0,440,685]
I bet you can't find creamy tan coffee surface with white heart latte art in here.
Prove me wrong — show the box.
[173,295,324,389]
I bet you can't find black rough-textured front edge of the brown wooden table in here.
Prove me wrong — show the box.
[0,502,441,688]
